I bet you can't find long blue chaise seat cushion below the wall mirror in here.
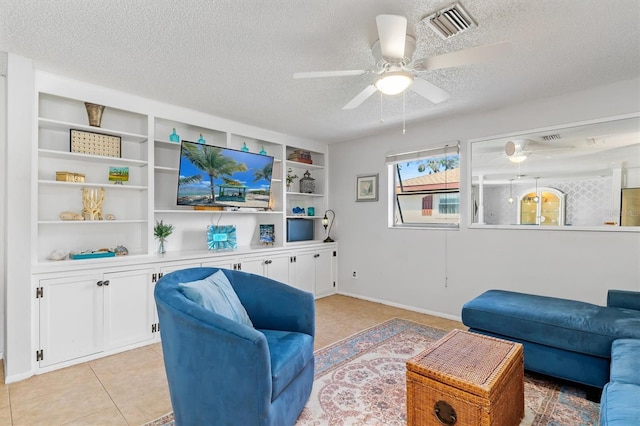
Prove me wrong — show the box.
[462,290,640,359]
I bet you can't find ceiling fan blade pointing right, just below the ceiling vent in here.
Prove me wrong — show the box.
[413,41,512,71]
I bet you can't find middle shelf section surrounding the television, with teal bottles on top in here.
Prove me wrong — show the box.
[153,117,284,251]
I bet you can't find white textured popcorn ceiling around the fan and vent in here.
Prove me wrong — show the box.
[0,0,640,142]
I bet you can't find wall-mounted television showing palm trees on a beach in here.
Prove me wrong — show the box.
[177,141,273,209]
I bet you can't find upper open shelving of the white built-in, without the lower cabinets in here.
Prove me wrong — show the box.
[34,87,327,263]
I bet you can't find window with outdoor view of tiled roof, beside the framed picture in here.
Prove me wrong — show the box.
[387,145,460,228]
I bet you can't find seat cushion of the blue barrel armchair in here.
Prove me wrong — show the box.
[259,330,313,401]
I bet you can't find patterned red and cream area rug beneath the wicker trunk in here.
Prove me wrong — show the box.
[146,319,599,426]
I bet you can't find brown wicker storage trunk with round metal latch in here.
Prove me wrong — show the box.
[407,330,524,426]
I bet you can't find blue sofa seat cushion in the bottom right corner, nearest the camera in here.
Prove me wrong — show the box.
[600,382,640,426]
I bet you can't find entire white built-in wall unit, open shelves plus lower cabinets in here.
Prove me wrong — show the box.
[23,72,337,380]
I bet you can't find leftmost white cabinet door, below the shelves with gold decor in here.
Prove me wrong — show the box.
[39,274,104,367]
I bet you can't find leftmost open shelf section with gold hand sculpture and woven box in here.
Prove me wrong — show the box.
[35,92,149,263]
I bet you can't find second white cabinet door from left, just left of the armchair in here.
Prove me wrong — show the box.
[102,268,156,350]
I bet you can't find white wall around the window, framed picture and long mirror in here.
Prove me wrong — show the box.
[329,79,640,318]
